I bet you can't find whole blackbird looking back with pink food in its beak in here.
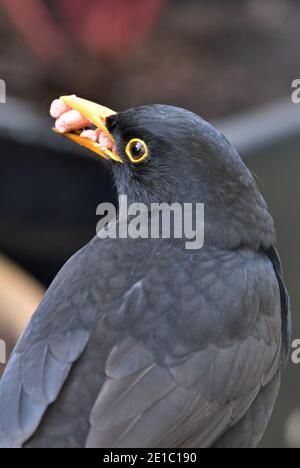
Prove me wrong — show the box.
[0,96,291,448]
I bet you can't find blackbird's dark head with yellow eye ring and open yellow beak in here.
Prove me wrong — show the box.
[53,96,274,248]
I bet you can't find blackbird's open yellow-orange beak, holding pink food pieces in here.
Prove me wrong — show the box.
[53,96,122,163]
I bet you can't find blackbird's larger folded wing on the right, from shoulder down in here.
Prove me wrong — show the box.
[87,247,281,447]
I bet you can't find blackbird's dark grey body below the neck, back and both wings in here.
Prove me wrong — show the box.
[0,238,288,447]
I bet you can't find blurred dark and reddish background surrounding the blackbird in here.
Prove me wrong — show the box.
[0,0,300,448]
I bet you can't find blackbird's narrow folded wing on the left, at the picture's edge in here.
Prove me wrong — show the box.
[0,245,97,448]
